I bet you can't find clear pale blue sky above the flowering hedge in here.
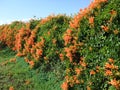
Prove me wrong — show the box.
[0,0,91,24]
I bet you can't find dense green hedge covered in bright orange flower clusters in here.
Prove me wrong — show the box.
[0,0,120,90]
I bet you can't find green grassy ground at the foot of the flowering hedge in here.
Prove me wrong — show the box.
[0,48,63,90]
